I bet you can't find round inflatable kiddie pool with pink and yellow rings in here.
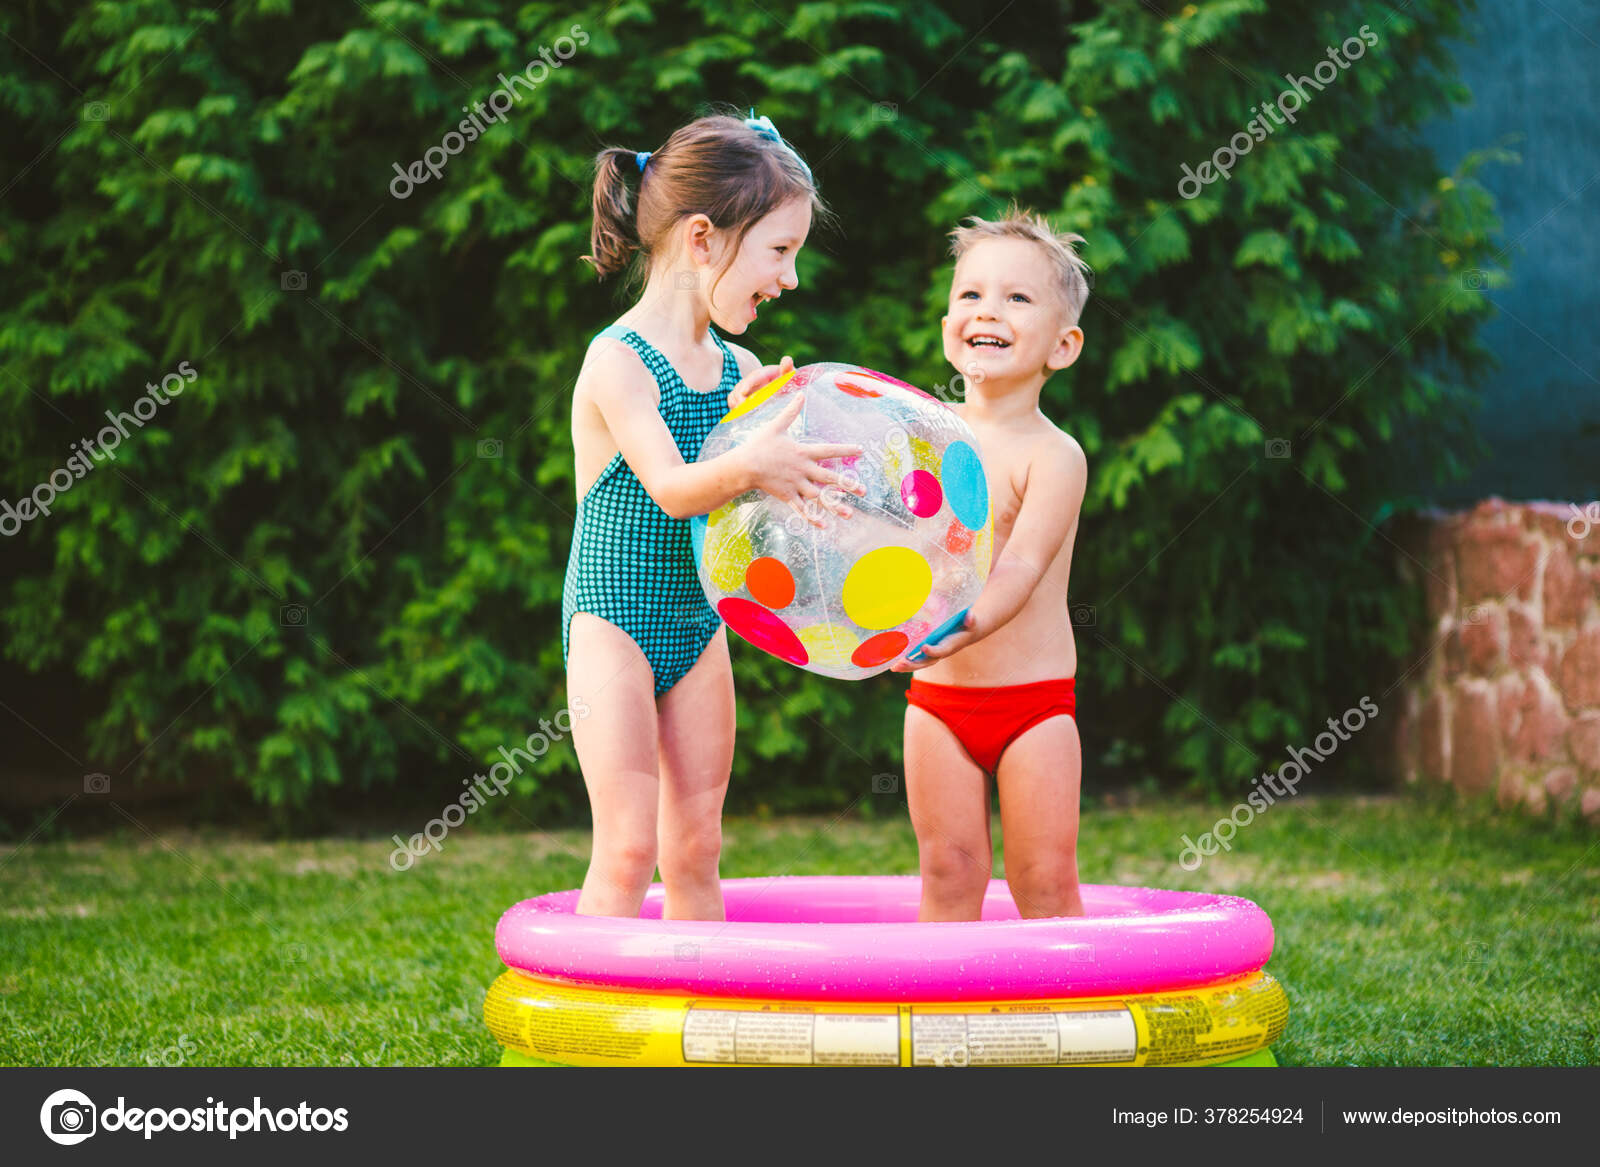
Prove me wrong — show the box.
[483,876,1288,1066]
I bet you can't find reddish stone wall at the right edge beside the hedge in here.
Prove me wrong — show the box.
[1395,498,1600,826]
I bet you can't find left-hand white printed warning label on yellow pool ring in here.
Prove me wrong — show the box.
[683,1007,899,1066]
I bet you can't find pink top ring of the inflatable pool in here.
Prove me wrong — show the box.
[494,876,1272,1001]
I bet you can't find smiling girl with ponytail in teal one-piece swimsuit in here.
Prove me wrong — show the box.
[562,110,861,920]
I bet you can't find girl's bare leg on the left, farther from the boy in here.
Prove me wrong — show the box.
[566,612,661,917]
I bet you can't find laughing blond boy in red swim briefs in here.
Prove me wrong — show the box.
[894,208,1088,920]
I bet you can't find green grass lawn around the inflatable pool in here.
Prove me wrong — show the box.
[0,796,1600,1066]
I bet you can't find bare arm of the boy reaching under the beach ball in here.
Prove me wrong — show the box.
[893,434,1088,672]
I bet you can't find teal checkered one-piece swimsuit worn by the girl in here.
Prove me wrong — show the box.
[562,325,739,696]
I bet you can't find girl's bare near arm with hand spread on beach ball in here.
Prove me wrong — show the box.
[586,340,862,525]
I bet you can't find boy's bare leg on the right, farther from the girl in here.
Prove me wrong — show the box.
[995,714,1083,917]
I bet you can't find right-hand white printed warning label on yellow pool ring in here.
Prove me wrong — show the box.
[910,1005,1139,1066]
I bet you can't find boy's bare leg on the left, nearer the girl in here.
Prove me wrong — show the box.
[904,704,994,920]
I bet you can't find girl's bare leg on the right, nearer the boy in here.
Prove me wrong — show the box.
[658,629,734,920]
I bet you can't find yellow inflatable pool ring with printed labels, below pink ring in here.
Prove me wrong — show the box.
[483,968,1288,1066]
